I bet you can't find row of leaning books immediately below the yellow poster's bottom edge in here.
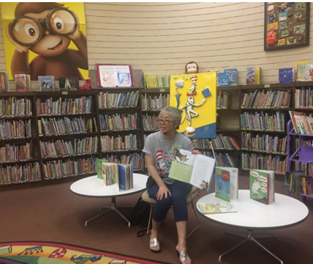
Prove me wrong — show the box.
[192,134,240,150]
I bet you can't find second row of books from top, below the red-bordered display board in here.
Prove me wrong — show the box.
[99,113,138,132]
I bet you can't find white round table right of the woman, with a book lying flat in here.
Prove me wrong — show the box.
[197,190,309,263]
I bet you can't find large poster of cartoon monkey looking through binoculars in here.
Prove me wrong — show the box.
[1,2,88,80]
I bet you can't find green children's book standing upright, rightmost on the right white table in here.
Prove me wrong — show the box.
[249,169,275,204]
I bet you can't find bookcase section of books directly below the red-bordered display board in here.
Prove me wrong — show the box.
[97,88,144,171]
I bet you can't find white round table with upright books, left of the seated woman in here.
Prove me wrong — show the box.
[70,173,148,227]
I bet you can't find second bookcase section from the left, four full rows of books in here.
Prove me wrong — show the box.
[36,91,99,180]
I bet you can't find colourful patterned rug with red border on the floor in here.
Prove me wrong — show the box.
[0,242,168,264]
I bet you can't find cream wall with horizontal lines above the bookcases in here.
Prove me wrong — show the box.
[0,3,313,84]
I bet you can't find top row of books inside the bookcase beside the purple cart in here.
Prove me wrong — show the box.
[241,90,291,109]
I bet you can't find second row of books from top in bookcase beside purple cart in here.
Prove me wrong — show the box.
[240,111,285,132]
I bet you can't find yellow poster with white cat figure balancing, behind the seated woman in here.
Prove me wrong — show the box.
[170,72,216,138]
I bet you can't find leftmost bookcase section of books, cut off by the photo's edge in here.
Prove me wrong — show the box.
[0,92,41,185]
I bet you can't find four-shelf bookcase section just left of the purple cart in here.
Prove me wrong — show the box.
[240,83,294,175]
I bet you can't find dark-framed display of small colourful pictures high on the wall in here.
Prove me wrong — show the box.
[264,2,310,51]
